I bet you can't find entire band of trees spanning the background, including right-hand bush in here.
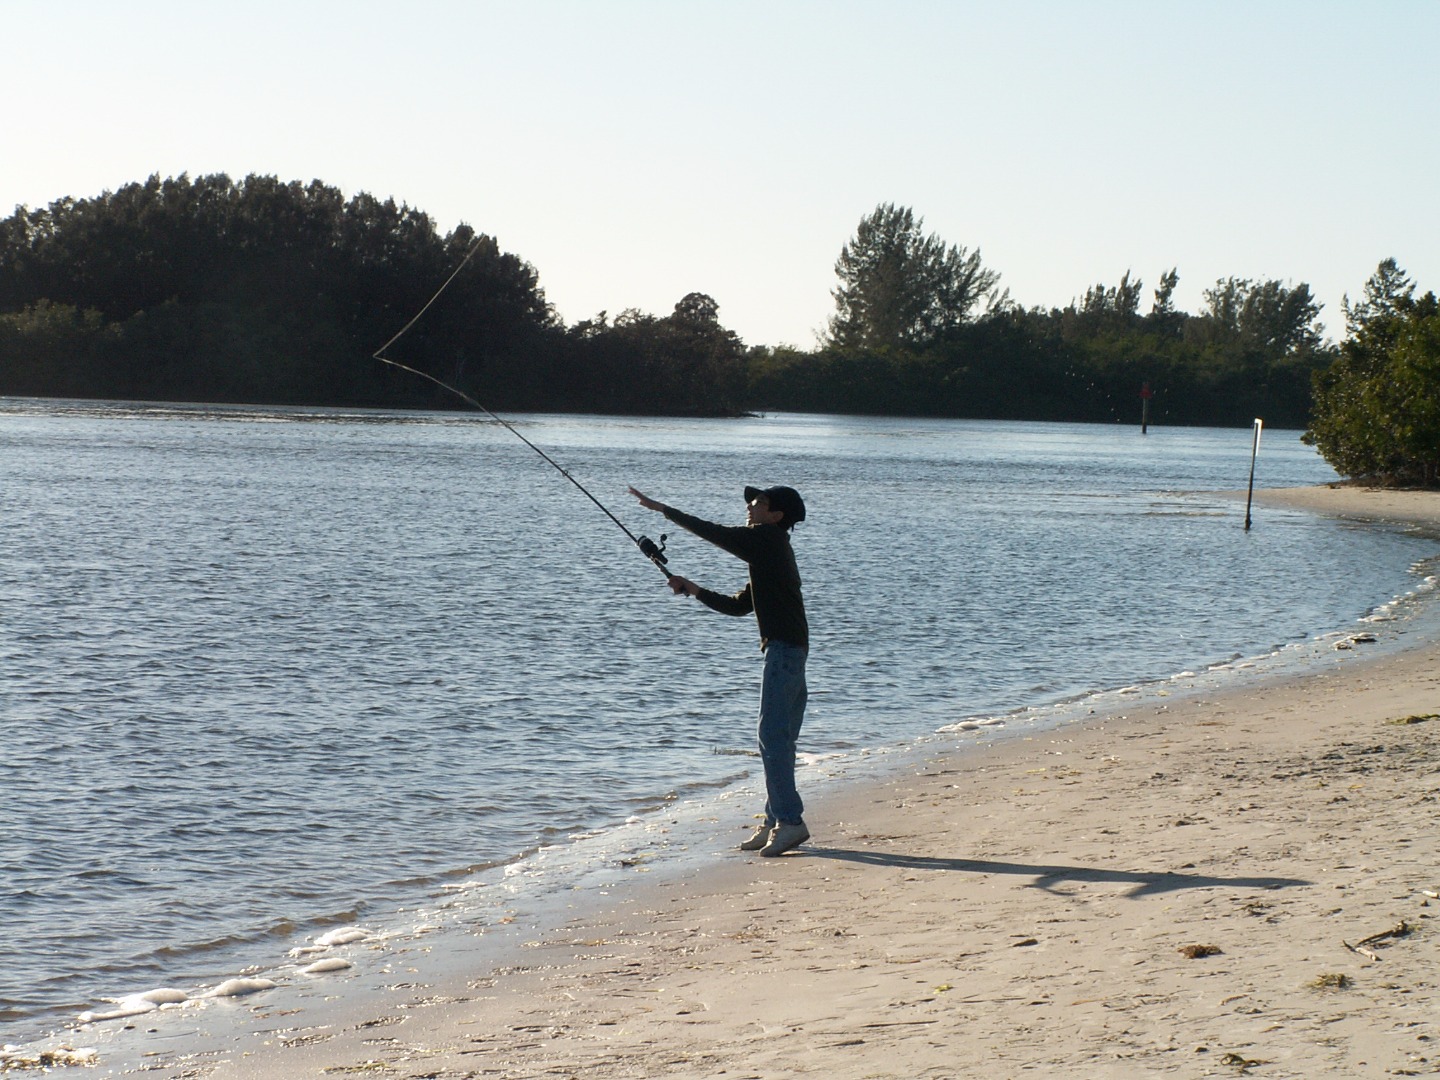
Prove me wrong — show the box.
[0,174,1434,477]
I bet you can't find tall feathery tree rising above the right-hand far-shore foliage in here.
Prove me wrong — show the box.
[828,203,999,348]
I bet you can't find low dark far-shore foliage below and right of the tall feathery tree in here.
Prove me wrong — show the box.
[750,262,1332,428]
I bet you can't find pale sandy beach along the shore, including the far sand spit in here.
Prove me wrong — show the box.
[14,487,1440,1080]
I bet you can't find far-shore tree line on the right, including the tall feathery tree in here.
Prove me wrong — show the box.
[750,204,1332,426]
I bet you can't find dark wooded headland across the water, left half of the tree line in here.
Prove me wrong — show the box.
[0,174,744,413]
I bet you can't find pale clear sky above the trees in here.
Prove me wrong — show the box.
[0,0,1440,347]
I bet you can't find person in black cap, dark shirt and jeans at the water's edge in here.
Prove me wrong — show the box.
[629,487,809,855]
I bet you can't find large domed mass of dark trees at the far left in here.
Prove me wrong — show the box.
[0,176,554,405]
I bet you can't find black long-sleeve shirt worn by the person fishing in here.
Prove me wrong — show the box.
[664,507,809,649]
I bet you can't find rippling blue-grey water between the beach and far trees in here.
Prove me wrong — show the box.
[0,399,1437,1041]
